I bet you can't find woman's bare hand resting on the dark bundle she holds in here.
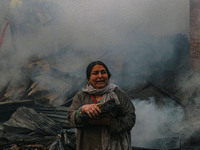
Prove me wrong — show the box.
[81,103,101,118]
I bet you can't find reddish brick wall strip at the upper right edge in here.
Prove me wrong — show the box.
[190,0,200,70]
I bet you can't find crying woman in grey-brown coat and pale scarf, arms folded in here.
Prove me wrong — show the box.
[68,61,135,150]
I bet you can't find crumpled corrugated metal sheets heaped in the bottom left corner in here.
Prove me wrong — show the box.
[0,107,75,150]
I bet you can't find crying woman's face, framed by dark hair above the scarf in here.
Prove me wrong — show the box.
[89,65,108,89]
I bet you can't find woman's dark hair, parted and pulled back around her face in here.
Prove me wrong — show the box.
[86,61,111,80]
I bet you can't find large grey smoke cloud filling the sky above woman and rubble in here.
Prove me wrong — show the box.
[0,0,189,98]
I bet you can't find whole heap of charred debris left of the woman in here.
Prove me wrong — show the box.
[0,58,80,150]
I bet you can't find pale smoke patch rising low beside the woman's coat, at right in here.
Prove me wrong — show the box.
[131,98,184,148]
